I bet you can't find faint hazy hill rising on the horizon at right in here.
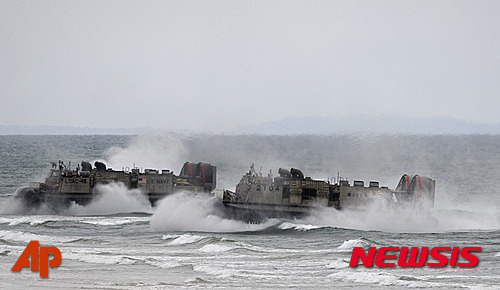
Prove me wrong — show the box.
[238,116,500,135]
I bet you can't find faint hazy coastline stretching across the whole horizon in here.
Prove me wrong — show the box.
[0,116,500,135]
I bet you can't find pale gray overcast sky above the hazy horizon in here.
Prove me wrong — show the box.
[0,0,500,132]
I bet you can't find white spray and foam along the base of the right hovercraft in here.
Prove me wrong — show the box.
[150,189,500,233]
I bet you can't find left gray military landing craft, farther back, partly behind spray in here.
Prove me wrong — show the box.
[14,161,217,207]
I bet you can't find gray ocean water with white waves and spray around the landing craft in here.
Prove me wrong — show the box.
[0,134,500,289]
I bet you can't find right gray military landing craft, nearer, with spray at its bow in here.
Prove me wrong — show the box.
[216,164,435,221]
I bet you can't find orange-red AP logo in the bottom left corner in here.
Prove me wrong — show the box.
[10,241,61,277]
